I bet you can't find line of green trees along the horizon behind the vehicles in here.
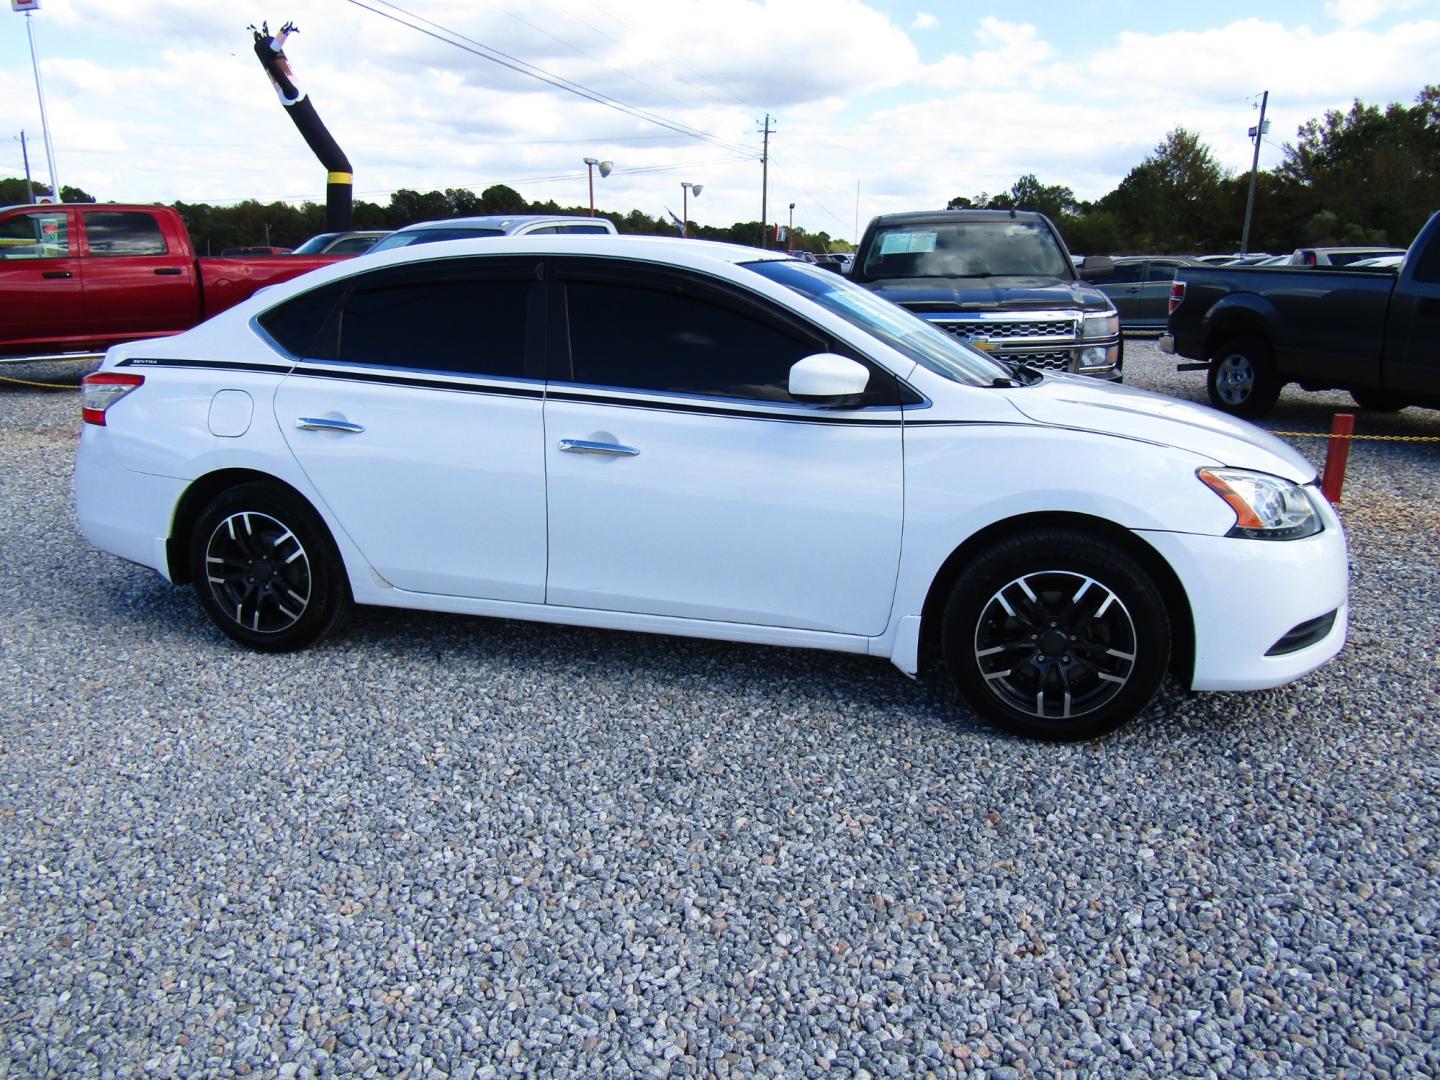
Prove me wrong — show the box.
[0,86,1440,255]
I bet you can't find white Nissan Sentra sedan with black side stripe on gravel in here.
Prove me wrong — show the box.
[75,236,1346,739]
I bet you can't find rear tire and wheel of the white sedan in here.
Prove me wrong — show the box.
[190,482,353,652]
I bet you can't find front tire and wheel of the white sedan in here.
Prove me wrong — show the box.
[940,528,1171,742]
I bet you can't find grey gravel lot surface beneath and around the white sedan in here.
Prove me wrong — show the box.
[0,340,1440,1077]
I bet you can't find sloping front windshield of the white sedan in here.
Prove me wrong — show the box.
[743,259,1009,386]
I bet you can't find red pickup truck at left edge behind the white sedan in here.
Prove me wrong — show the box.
[0,203,336,364]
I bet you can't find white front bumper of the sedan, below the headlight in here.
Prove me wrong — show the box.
[1140,500,1349,690]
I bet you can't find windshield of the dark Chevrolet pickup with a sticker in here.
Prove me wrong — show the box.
[860,219,1073,281]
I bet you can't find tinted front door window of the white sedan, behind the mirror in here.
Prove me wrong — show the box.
[566,281,819,402]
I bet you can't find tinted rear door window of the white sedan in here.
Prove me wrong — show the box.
[337,278,530,379]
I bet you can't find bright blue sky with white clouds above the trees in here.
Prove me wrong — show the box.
[0,0,1440,240]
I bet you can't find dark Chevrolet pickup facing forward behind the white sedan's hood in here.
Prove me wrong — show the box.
[850,210,1123,379]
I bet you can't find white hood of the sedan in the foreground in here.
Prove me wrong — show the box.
[1007,374,1315,484]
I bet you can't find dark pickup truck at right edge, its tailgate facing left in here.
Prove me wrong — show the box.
[1161,213,1440,418]
